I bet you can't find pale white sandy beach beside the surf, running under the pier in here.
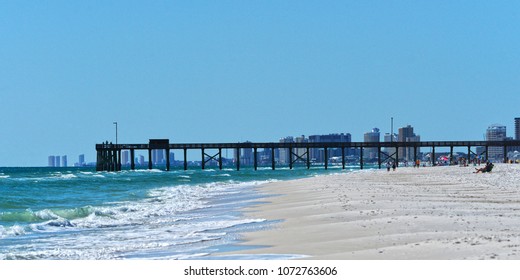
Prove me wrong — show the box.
[234,164,520,260]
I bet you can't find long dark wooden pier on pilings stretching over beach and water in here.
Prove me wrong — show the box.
[96,139,520,171]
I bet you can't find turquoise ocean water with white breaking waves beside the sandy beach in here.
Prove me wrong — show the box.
[0,167,364,260]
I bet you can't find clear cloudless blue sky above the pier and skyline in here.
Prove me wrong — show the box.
[0,0,520,166]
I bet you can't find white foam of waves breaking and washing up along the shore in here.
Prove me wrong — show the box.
[0,170,275,259]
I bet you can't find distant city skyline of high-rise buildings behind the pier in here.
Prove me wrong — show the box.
[48,118,520,167]
